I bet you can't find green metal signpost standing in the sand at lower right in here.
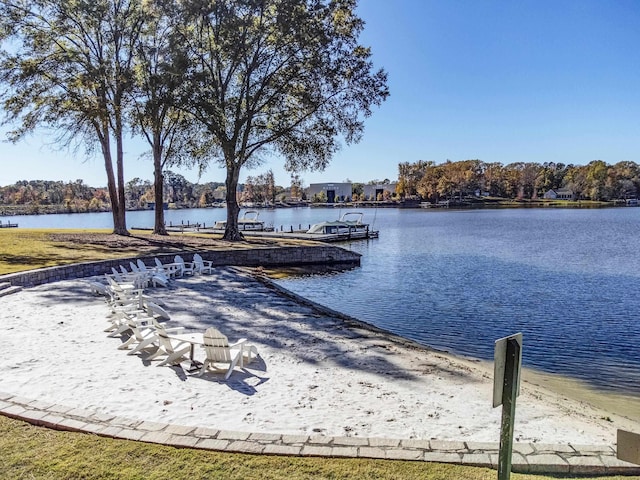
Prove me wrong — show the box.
[498,338,520,480]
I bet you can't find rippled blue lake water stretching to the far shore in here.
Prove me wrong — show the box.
[2,208,640,397]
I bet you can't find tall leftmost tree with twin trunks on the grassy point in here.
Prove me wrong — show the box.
[0,0,144,235]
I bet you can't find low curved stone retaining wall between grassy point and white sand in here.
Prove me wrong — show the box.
[0,245,360,287]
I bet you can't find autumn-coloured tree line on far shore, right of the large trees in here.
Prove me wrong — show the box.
[397,160,640,202]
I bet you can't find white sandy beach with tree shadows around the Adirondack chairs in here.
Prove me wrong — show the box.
[0,268,640,445]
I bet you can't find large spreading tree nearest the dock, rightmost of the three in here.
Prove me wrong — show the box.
[172,0,388,240]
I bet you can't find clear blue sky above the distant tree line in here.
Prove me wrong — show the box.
[0,0,640,186]
